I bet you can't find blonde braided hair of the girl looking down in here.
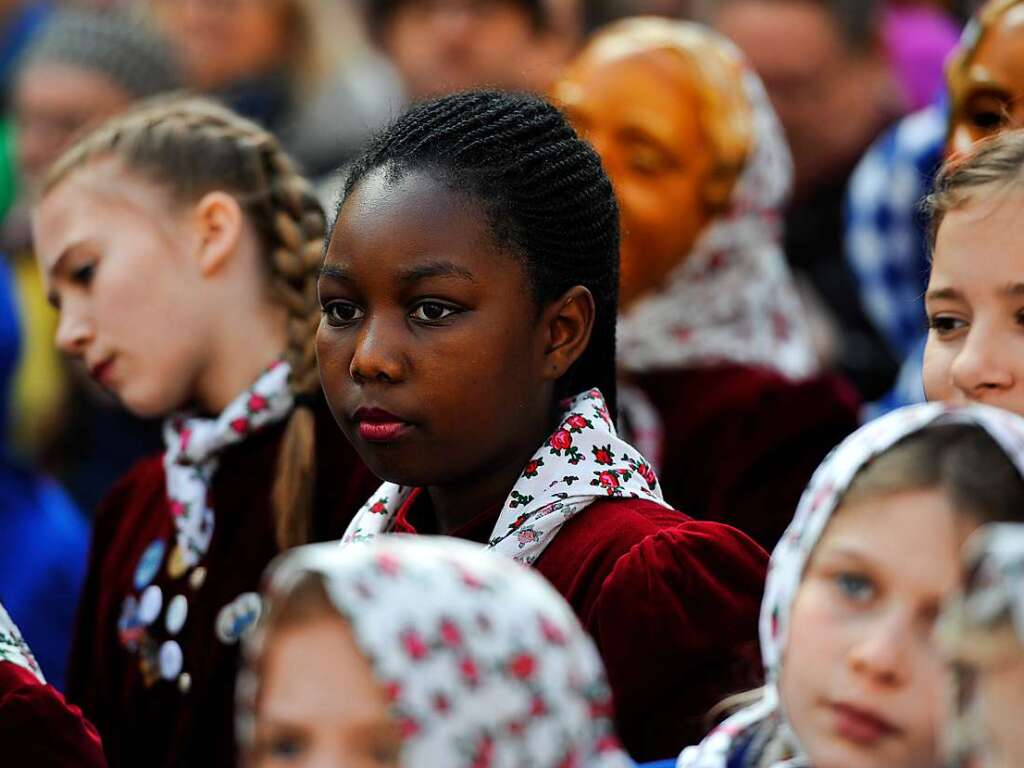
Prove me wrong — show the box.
[43,96,327,549]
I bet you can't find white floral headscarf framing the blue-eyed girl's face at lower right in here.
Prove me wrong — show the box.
[677,402,1024,768]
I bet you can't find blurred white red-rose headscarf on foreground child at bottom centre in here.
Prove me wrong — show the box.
[239,537,632,768]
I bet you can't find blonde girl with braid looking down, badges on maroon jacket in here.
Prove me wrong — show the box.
[33,97,375,766]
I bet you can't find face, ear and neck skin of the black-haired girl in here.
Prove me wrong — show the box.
[316,170,594,534]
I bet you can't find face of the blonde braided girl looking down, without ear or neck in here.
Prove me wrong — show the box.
[33,161,206,416]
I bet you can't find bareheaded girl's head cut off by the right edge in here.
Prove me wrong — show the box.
[924,131,1024,414]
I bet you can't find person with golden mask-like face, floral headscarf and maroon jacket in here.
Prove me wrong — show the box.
[552,17,859,550]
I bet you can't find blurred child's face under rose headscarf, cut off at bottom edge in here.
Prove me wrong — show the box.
[248,616,401,768]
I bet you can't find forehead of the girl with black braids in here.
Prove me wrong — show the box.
[327,168,518,274]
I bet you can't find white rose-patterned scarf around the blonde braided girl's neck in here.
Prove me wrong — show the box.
[164,361,295,568]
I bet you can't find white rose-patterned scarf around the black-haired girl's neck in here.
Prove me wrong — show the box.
[342,389,669,565]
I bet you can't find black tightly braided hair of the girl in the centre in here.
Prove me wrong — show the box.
[339,91,618,413]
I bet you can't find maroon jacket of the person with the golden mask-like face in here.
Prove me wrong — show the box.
[632,365,860,551]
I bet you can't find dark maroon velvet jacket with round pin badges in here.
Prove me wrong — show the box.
[69,403,380,768]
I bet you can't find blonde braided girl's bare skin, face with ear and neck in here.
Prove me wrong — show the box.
[33,159,287,417]
